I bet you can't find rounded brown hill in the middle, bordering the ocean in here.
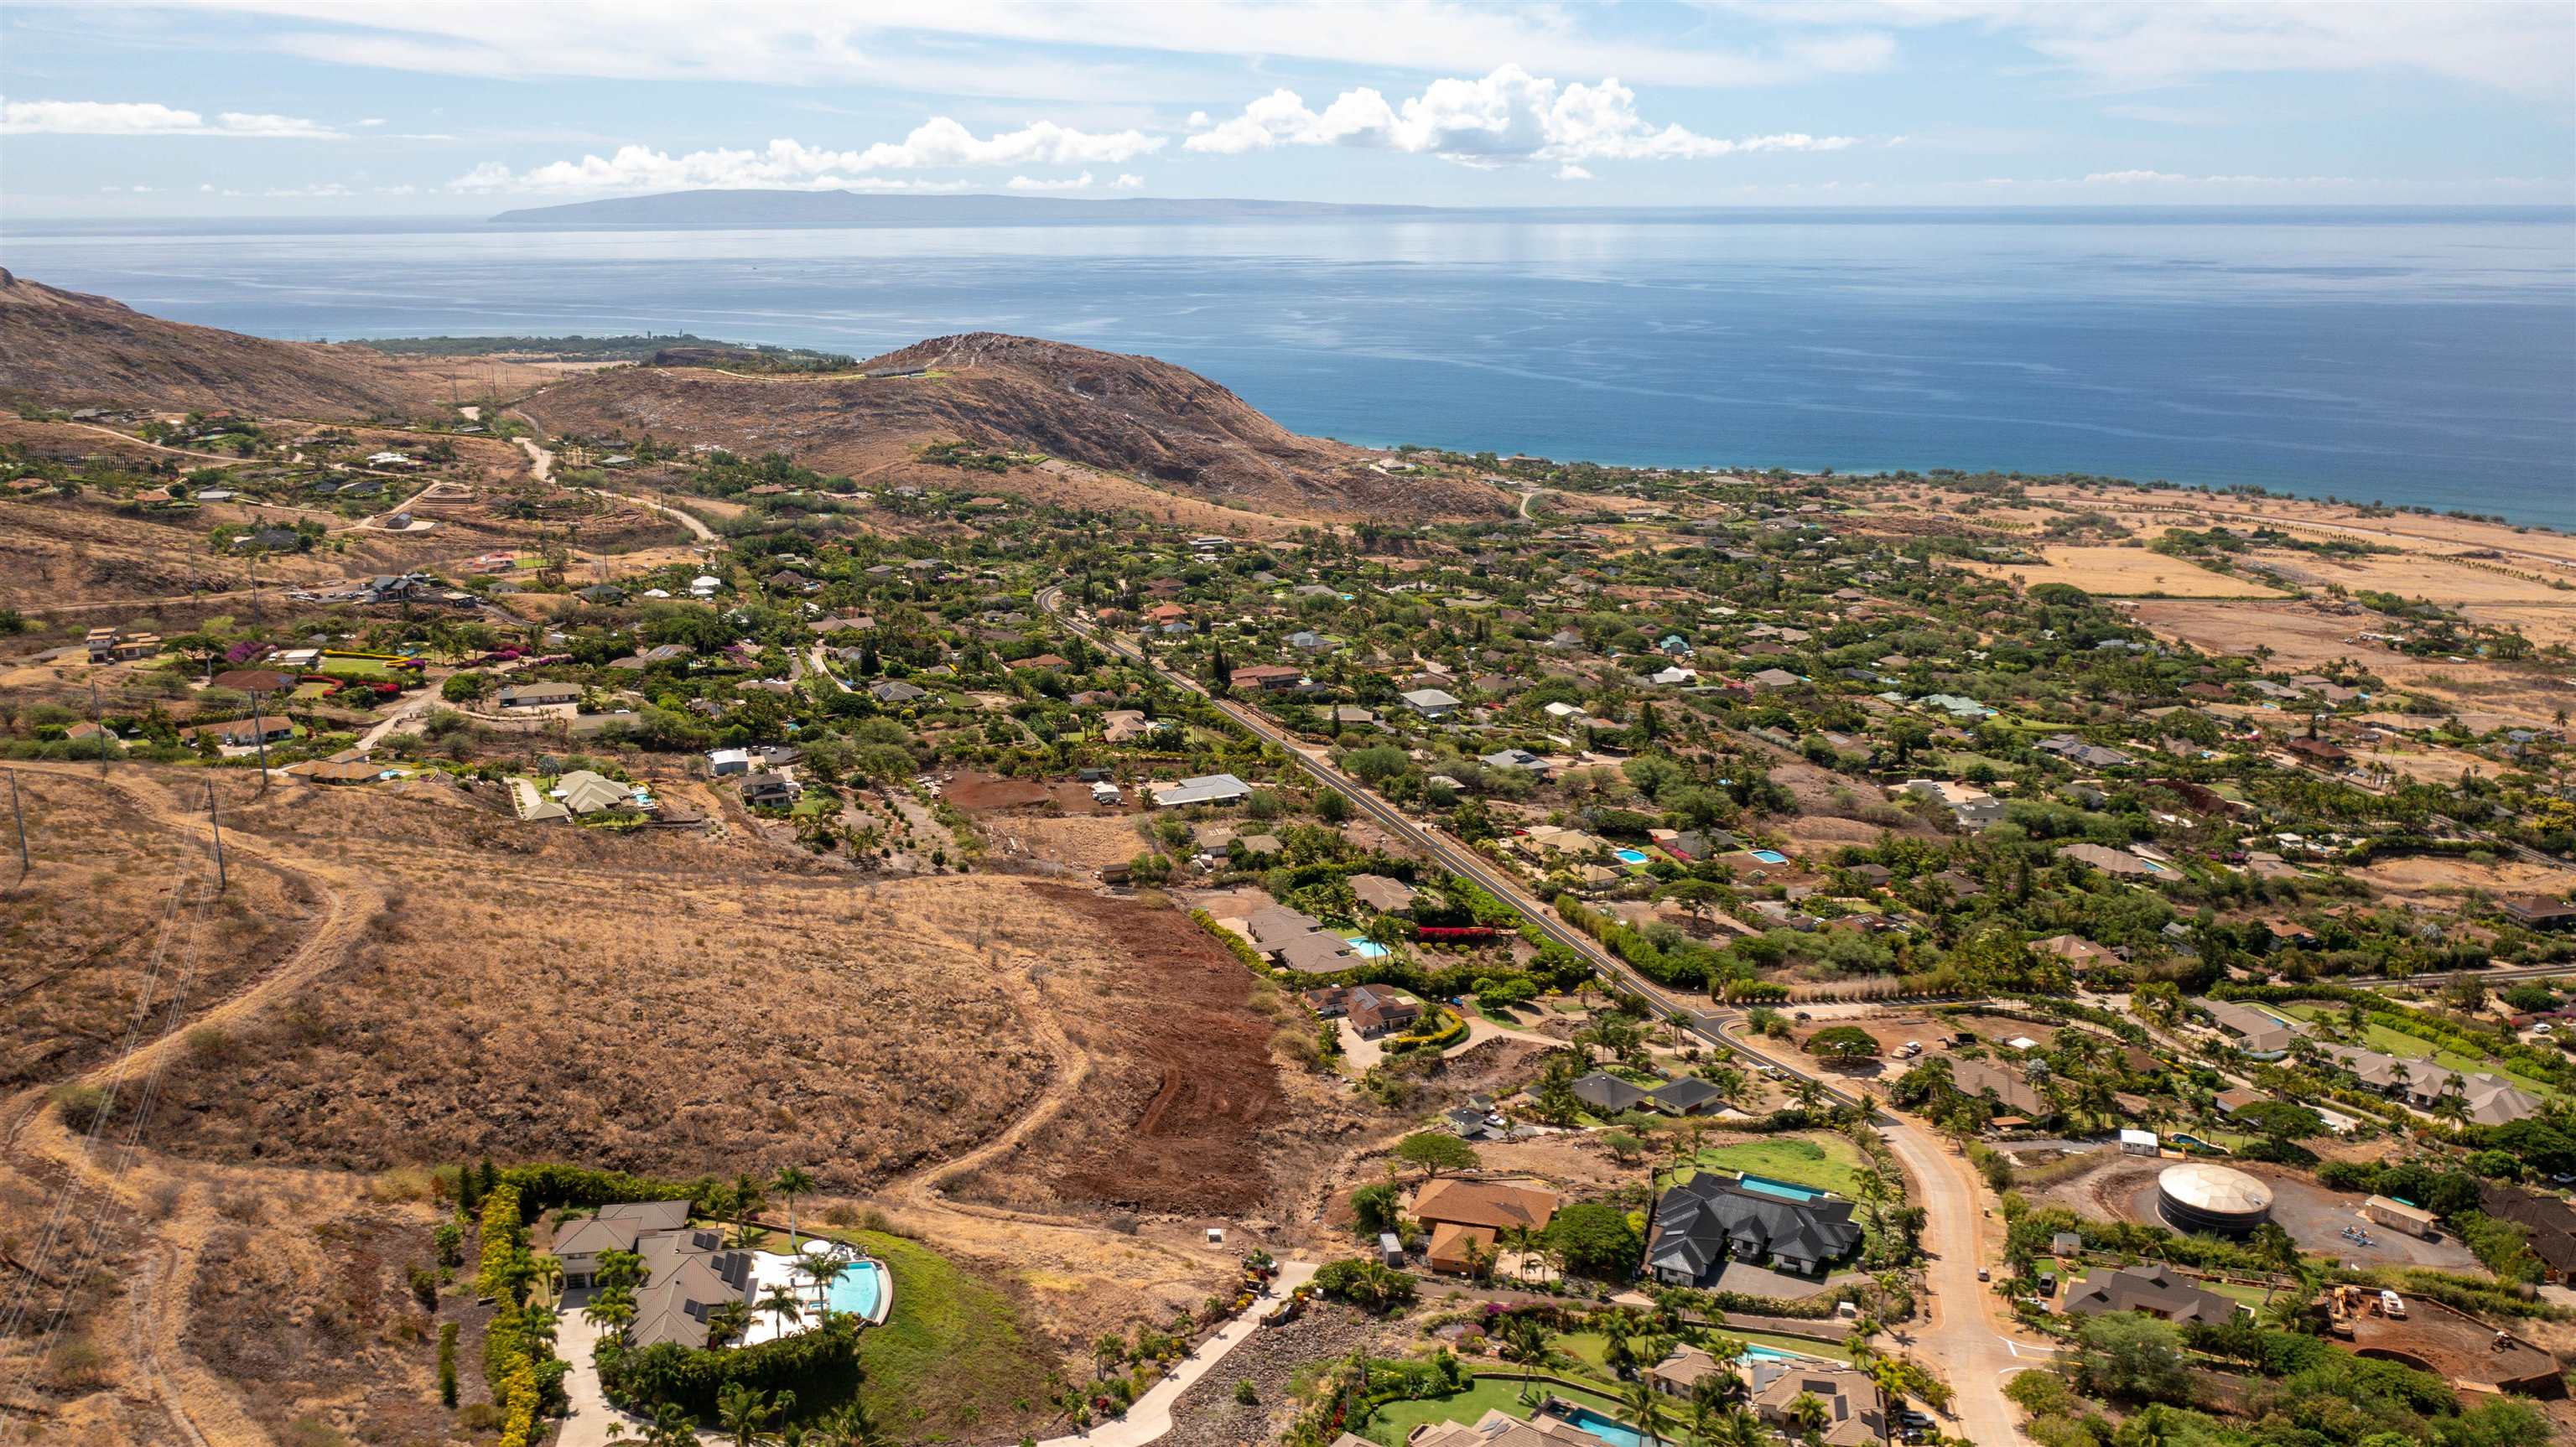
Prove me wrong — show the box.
[528,332,1507,517]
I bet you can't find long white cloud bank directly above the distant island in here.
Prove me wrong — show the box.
[449,116,1165,190]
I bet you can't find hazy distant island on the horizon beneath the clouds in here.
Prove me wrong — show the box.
[492,190,1453,226]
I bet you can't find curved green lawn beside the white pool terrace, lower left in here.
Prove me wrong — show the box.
[776,1231,1053,1439]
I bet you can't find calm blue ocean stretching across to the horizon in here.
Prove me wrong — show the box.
[0,209,2576,528]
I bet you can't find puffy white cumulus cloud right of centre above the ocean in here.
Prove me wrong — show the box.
[1182,65,1857,168]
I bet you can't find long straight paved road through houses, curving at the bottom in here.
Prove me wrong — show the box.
[1038,587,2045,1444]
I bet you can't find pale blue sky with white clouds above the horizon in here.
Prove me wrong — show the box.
[0,0,2576,216]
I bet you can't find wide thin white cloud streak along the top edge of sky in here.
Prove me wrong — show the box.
[49,0,1893,103]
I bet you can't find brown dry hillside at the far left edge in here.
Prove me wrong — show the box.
[0,270,433,418]
